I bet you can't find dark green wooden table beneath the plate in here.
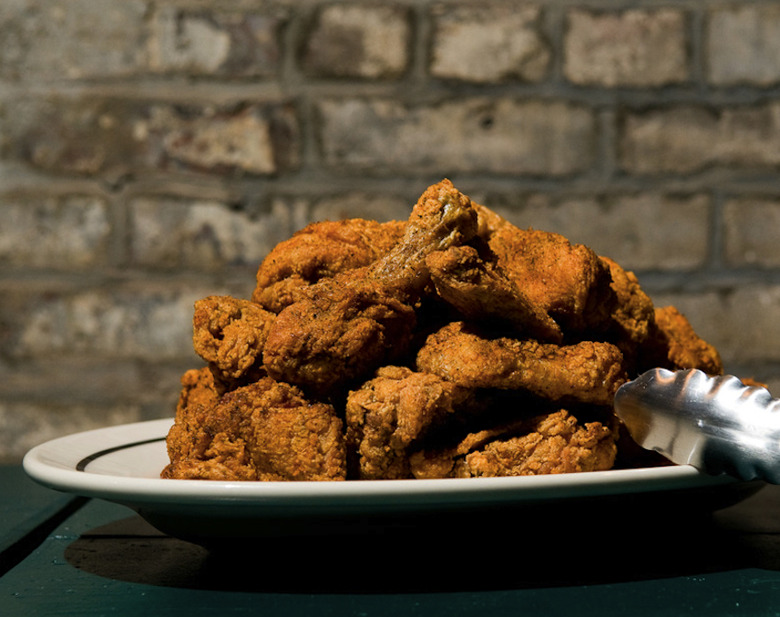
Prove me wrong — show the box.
[0,467,780,617]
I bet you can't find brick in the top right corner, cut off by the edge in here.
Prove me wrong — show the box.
[706,4,780,86]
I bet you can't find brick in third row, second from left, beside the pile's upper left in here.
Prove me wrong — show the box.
[130,197,302,271]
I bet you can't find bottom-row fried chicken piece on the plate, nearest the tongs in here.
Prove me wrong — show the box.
[410,409,617,479]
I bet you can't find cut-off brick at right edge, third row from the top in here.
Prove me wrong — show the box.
[723,197,780,268]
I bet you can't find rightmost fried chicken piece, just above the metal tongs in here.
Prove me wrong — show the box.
[640,306,723,375]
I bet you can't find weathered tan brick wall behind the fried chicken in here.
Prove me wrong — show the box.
[0,0,780,460]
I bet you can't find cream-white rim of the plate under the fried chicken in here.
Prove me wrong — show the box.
[23,418,739,508]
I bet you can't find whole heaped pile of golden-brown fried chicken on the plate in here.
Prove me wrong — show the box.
[162,180,723,480]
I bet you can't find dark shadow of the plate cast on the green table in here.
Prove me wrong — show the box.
[65,482,780,593]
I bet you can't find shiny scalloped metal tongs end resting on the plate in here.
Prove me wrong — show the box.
[615,368,780,484]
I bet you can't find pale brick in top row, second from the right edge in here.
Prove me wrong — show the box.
[563,9,689,88]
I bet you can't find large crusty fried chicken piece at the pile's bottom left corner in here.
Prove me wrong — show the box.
[162,377,346,480]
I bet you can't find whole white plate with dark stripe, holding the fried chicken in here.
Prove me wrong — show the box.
[24,419,760,540]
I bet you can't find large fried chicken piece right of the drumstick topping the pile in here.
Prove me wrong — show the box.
[488,222,612,333]
